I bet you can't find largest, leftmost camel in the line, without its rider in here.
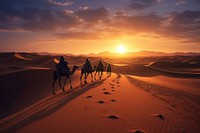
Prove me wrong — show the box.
[52,65,78,95]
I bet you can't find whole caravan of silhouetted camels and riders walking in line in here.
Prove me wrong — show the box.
[52,56,111,95]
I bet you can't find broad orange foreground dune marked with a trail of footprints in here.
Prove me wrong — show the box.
[0,74,199,133]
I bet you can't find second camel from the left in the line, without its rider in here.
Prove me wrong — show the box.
[80,64,96,85]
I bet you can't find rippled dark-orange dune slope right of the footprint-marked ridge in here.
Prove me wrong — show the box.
[127,76,200,127]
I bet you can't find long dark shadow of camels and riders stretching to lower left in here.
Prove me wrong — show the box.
[0,78,107,133]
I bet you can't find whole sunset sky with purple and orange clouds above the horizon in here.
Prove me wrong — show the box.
[0,0,200,54]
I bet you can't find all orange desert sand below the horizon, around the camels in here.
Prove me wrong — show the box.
[0,53,200,133]
